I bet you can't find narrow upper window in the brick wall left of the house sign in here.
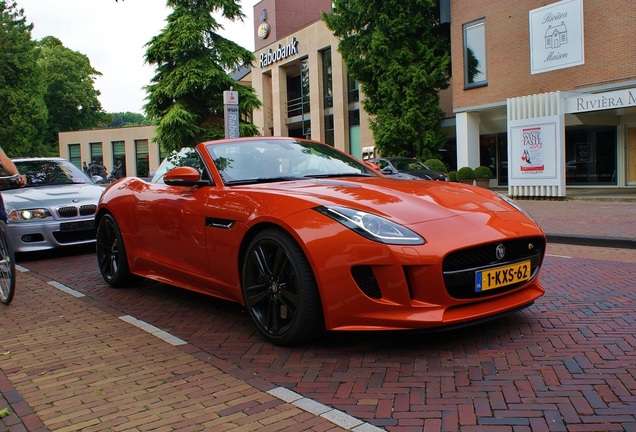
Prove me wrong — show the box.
[463,19,488,88]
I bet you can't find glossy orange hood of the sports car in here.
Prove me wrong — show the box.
[248,177,517,225]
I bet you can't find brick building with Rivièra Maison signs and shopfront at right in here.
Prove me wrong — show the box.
[451,0,636,194]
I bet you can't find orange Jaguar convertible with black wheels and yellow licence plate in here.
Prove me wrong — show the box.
[96,137,546,345]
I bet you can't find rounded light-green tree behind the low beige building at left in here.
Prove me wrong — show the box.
[37,36,107,151]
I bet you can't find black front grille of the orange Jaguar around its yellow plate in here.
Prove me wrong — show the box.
[442,237,545,299]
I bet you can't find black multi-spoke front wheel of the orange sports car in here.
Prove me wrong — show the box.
[241,229,324,345]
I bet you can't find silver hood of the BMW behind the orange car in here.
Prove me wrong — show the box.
[2,184,104,208]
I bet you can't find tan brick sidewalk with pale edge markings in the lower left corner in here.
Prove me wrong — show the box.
[0,272,352,432]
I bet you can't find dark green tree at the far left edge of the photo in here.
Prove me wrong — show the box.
[0,0,47,156]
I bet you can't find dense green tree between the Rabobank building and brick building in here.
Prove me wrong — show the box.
[323,0,450,159]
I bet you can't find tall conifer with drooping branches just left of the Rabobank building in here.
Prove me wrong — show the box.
[145,0,261,151]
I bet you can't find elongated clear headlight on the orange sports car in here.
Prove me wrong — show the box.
[315,206,426,245]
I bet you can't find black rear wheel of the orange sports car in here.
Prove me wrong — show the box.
[97,214,140,288]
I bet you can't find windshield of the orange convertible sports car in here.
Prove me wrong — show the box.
[207,138,377,184]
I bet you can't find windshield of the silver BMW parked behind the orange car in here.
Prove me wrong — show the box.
[3,159,93,189]
